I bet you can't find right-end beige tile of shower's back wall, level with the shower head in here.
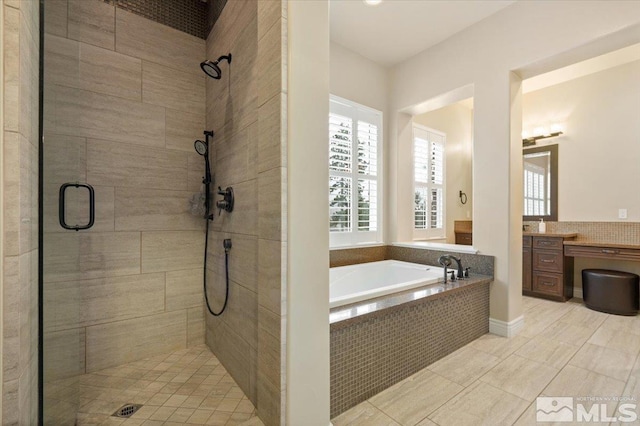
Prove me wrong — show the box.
[142,61,205,116]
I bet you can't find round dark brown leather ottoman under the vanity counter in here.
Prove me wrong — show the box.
[582,269,640,315]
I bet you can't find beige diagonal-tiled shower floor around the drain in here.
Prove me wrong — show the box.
[78,345,262,426]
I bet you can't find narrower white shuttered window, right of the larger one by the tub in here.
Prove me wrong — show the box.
[413,124,446,239]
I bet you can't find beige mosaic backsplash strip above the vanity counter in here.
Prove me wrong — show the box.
[523,222,640,244]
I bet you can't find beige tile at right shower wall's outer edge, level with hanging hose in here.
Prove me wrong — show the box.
[258,239,287,315]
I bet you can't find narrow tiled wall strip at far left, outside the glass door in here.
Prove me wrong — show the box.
[0,0,39,425]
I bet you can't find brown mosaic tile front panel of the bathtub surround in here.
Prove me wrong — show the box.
[330,284,489,418]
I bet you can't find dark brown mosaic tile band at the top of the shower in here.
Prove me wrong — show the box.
[103,0,220,39]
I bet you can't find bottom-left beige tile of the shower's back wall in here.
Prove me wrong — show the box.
[44,328,85,383]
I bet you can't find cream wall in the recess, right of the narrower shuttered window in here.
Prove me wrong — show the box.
[413,102,473,244]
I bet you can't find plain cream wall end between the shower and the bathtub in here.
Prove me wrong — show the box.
[285,0,329,426]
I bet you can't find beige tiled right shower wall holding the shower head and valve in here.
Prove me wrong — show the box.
[206,0,287,425]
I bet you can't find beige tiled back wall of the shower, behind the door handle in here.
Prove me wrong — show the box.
[42,0,205,380]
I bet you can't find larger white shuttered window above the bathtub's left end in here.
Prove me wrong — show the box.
[329,96,382,246]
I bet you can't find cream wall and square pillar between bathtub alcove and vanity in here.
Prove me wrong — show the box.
[388,1,640,322]
